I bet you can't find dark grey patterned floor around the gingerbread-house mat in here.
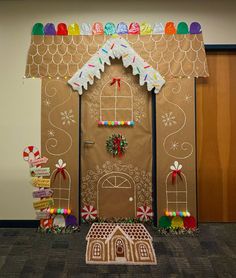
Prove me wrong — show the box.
[0,223,236,278]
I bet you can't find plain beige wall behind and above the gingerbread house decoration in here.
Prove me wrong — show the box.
[0,0,236,219]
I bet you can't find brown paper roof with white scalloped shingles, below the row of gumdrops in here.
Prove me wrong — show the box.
[25,34,208,78]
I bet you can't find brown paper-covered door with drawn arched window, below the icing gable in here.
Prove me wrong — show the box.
[81,60,152,218]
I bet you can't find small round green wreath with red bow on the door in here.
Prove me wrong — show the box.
[106,134,128,156]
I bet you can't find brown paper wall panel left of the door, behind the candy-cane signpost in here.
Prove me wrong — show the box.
[41,78,79,217]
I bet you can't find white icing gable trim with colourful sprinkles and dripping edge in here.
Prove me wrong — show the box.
[68,37,165,95]
